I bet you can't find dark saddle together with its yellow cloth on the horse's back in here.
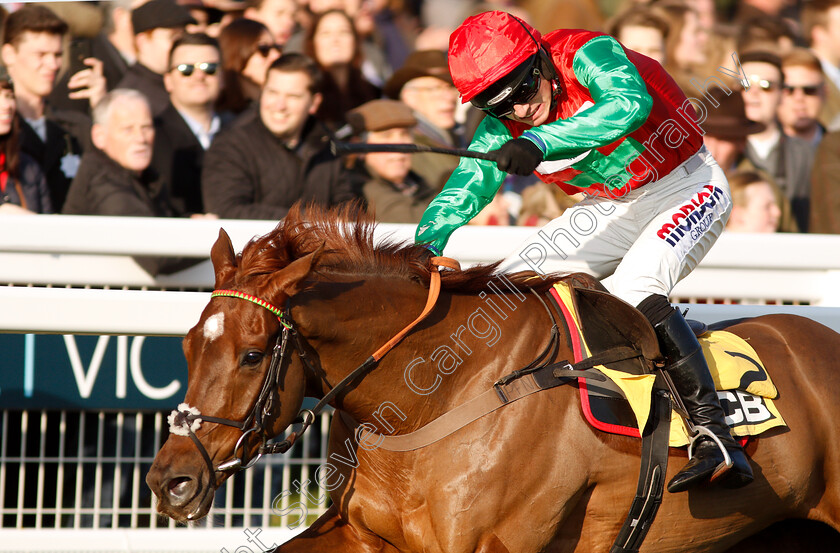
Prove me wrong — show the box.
[552,282,785,447]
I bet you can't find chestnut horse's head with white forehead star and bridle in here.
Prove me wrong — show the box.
[146,226,321,521]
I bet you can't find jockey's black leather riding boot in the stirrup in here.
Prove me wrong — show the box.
[639,296,753,493]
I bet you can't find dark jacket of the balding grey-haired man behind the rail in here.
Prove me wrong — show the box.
[62,148,201,276]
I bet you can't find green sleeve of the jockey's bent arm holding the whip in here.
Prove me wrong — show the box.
[522,36,653,159]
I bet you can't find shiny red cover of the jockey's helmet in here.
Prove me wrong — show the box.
[449,11,541,103]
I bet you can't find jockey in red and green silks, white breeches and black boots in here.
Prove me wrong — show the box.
[415,11,753,492]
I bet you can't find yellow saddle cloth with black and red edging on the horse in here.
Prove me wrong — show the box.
[552,282,785,447]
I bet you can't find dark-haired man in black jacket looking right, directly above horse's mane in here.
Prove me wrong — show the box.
[201,54,354,220]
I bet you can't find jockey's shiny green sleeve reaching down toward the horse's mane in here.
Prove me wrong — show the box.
[415,117,513,252]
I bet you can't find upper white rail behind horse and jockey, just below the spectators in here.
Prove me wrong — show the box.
[0,215,840,304]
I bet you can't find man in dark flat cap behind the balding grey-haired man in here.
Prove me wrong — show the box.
[118,0,195,117]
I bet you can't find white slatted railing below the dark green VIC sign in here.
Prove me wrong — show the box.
[0,410,330,553]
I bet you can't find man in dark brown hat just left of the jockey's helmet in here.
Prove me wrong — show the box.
[384,50,467,191]
